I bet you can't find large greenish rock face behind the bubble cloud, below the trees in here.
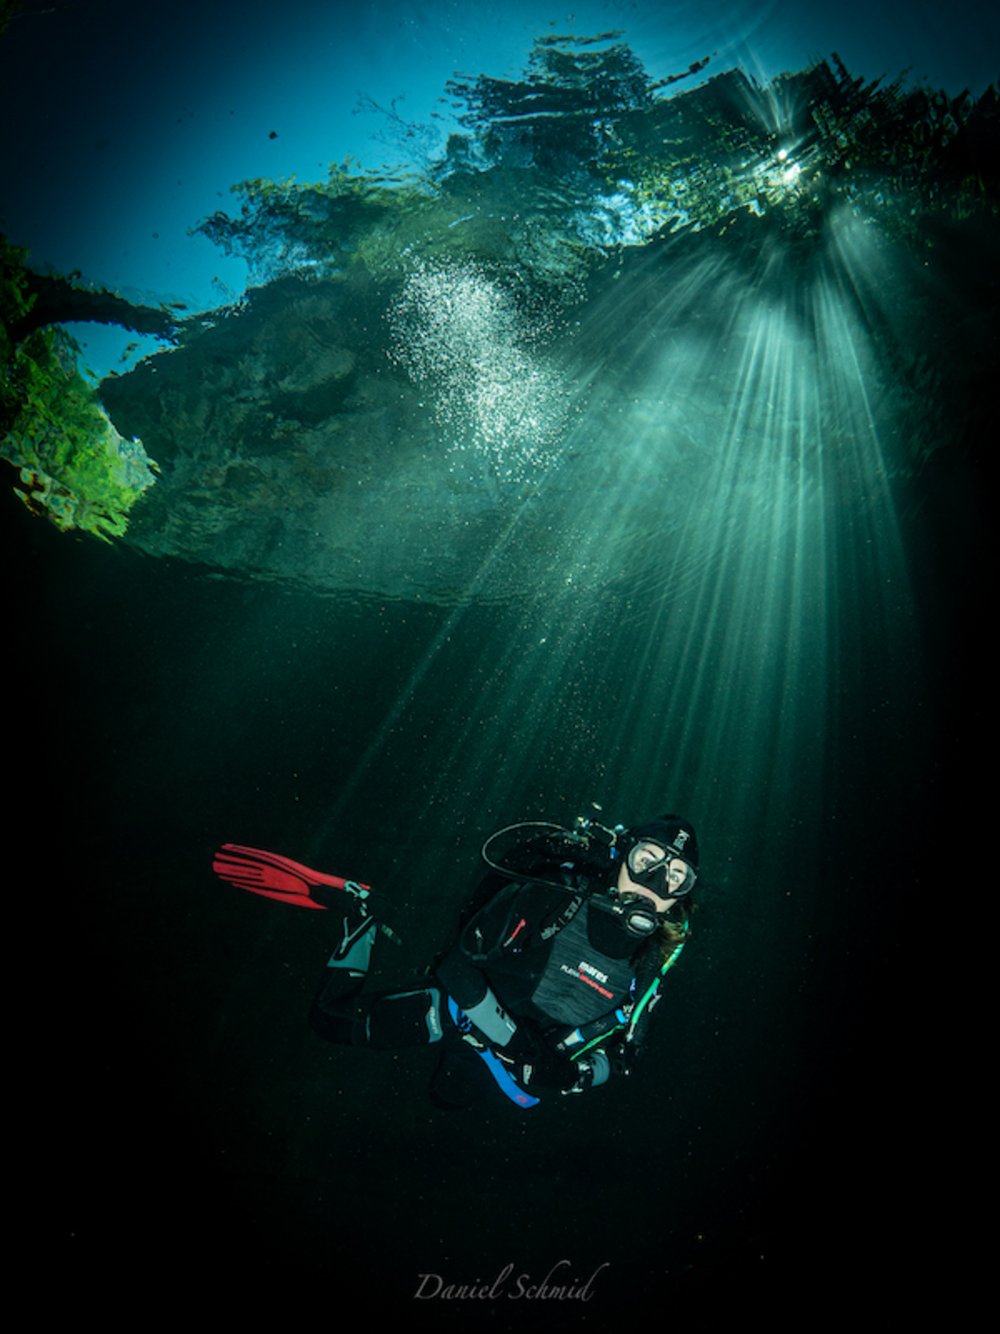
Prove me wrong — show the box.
[103,209,997,603]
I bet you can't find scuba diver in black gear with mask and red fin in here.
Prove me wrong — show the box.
[215,815,699,1109]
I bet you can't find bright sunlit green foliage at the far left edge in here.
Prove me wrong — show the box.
[0,236,153,542]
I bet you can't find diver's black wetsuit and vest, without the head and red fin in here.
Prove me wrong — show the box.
[312,840,685,1107]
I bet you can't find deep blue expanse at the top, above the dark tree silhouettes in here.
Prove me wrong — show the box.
[0,0,1000,375]
